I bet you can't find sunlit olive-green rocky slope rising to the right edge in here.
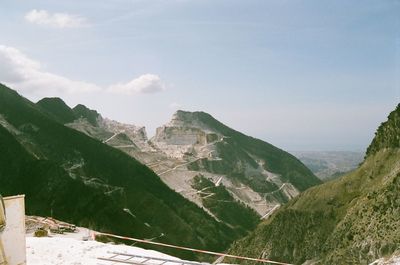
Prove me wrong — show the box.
[231,103,400,264]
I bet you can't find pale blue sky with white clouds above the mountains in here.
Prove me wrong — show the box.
[0,0,400,151]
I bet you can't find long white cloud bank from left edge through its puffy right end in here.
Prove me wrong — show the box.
[0,45,165,97]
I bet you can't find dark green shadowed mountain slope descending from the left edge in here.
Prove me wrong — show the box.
[0,85,237,258]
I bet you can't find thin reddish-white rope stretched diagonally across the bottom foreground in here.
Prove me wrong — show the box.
[96,232,292,265]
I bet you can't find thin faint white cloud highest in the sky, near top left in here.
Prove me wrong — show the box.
[25,9,87,28]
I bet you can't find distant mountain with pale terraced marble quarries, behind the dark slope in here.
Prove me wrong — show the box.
[37,95,321,225]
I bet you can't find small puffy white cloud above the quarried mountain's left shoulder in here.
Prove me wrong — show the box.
[108,74,166,95]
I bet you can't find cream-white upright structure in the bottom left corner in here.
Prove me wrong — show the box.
[0,195,26,265]
